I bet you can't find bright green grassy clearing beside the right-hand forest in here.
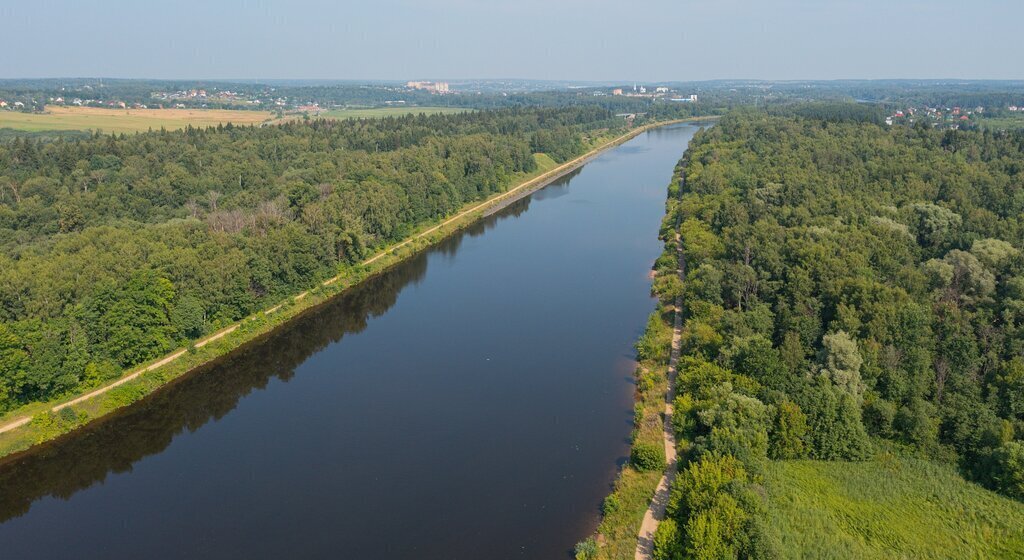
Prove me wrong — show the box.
[766,453,1024,559]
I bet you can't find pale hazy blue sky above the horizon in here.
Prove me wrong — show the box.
[0,0,1024,81]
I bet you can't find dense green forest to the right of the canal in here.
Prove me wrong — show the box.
[655,106,1024,559]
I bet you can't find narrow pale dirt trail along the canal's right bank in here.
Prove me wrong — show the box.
[633,234,685,560]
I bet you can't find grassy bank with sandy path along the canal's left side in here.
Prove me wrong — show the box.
[0,116,712,457]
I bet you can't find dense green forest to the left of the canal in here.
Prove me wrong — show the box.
[0,106,625,412]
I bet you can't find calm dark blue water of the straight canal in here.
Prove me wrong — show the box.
[0,125,697,560]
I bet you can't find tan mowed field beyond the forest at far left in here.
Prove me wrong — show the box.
[0,106,271,133]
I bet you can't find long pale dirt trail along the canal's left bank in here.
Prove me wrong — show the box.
[0,119,686,434]
